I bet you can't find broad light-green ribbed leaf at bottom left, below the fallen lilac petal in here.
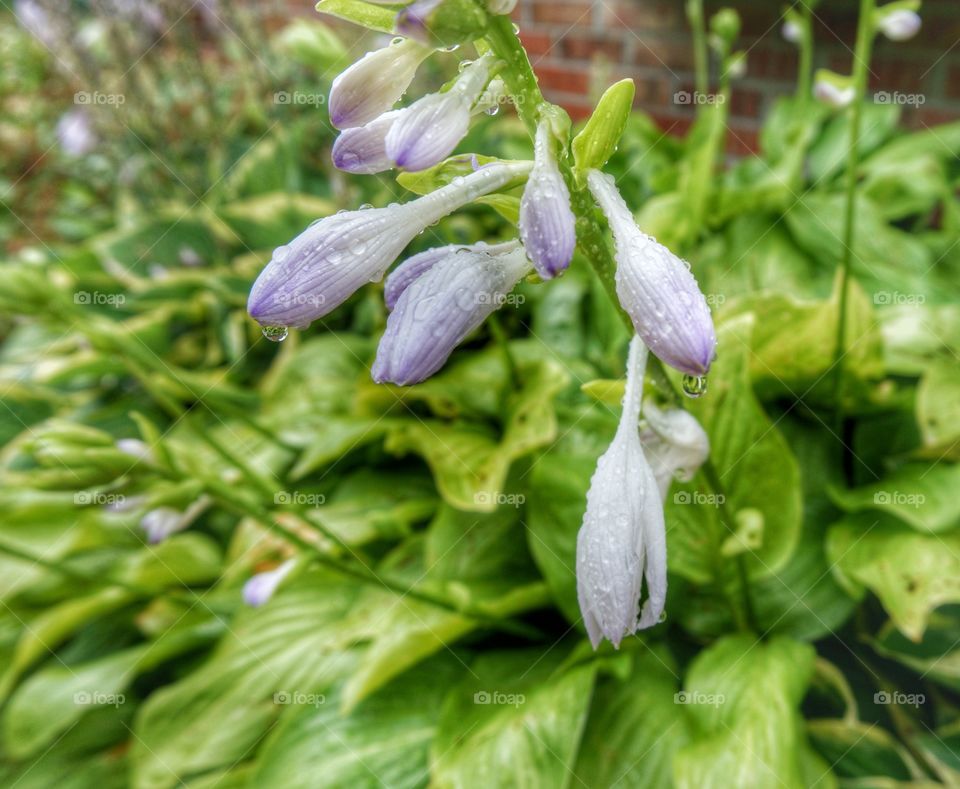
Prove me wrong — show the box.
[130,573,366,789]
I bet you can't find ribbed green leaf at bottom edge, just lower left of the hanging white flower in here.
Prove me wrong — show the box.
[431,649,596,789]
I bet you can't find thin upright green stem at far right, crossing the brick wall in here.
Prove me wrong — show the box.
[833,0,875,436]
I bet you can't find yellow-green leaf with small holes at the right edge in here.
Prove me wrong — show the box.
[827,515,960,641]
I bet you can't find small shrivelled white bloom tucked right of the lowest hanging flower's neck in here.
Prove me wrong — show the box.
[640,399,710,499]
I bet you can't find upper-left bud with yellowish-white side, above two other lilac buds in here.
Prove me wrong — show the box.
[330,39,430,129]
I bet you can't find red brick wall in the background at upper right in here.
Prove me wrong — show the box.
[515,0,960,153]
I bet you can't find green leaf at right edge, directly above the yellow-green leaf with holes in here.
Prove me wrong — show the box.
[830,463,960,532]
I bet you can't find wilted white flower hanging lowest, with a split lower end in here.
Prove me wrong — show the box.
[577,337,667,649]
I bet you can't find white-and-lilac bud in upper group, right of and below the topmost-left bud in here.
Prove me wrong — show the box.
[386,57,490,170]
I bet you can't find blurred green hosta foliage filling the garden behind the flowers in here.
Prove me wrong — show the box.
[0,0,960,789]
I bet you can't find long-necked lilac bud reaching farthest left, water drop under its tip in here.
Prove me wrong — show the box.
[247,164,529,328]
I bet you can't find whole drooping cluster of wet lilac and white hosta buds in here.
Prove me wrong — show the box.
[248,0,716,646]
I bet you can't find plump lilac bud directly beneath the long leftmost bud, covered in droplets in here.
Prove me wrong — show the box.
[371,241,530,386]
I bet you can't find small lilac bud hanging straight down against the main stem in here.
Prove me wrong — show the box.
[520,122,577,279]
